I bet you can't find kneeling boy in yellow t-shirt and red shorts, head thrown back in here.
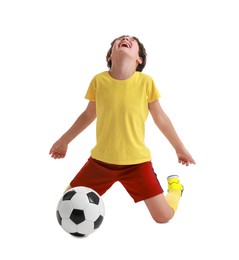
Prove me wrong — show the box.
[50,36,195,223]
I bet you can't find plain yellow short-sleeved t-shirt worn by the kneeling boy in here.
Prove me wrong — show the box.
[85,71,160,165]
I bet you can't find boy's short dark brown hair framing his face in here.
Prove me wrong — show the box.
[106,35,147,71]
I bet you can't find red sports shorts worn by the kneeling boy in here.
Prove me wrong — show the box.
[70,157,163,202]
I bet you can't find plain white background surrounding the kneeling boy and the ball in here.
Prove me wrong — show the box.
[0,0,239,260]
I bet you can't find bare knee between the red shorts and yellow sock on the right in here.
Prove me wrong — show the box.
[144,194,174,223]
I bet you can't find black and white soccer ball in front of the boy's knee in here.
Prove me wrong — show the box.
[56,186,105,237]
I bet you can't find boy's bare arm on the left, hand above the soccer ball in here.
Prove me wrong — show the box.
[49,101,96,159]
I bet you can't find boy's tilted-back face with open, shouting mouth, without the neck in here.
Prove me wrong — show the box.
[109,36,142,64]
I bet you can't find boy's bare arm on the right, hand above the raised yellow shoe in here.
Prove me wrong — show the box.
[149,100,195,166]
